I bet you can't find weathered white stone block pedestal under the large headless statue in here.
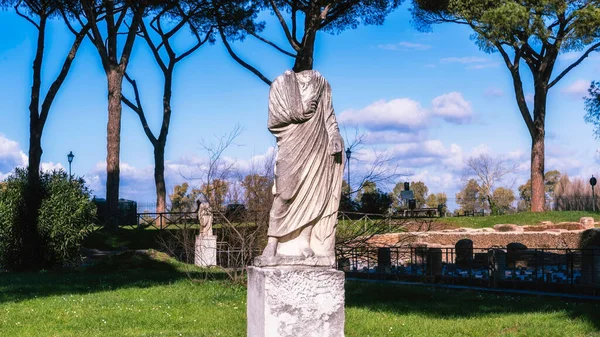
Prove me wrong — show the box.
[247,266,344,337]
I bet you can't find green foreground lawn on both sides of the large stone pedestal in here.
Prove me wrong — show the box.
[0,255,600,337]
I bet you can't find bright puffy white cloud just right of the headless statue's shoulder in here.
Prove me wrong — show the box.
[338,98,428,132]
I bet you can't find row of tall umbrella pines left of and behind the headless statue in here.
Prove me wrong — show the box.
[0,0,401,231]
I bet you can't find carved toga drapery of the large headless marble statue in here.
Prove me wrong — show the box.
[268,70,344,255]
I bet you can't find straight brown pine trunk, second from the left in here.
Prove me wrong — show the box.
[105,66,123,228]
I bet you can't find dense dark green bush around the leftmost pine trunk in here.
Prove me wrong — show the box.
[0,169,96,269]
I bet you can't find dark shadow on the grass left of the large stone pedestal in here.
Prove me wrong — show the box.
[0,251,228,304]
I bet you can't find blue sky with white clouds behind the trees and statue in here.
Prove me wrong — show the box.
[0,6,600,209]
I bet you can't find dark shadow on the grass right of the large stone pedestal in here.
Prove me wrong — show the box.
[346,281,600,331]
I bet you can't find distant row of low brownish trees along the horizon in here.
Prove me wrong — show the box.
[168,165,600,214]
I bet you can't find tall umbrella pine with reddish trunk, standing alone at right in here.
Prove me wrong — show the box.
[413,0,600,212]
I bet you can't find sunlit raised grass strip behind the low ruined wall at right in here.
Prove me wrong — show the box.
[437,211,600,228]
